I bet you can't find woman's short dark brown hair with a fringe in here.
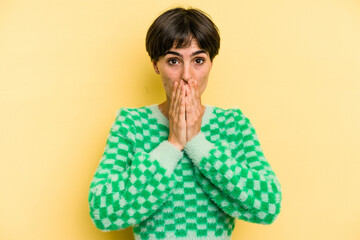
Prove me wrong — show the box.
[146,7,220,61]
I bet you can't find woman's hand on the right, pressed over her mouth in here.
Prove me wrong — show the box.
[185,80,204,142]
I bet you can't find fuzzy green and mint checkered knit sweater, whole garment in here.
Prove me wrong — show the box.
[88,105,282,240]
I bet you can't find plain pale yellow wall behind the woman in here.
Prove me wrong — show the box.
[0,0,360,240]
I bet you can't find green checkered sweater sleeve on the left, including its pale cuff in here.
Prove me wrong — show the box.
[88,108,183,232]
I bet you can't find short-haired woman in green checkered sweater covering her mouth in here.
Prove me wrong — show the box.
[89,8,282,240]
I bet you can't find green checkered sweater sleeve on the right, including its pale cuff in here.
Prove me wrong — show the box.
[184,109,282,224]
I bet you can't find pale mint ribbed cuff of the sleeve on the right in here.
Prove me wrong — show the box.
[184,132,215,167]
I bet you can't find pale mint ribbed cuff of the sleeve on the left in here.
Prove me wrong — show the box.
[150,141,184,172]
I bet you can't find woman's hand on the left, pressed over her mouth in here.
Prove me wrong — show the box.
[168,80,186,151]
